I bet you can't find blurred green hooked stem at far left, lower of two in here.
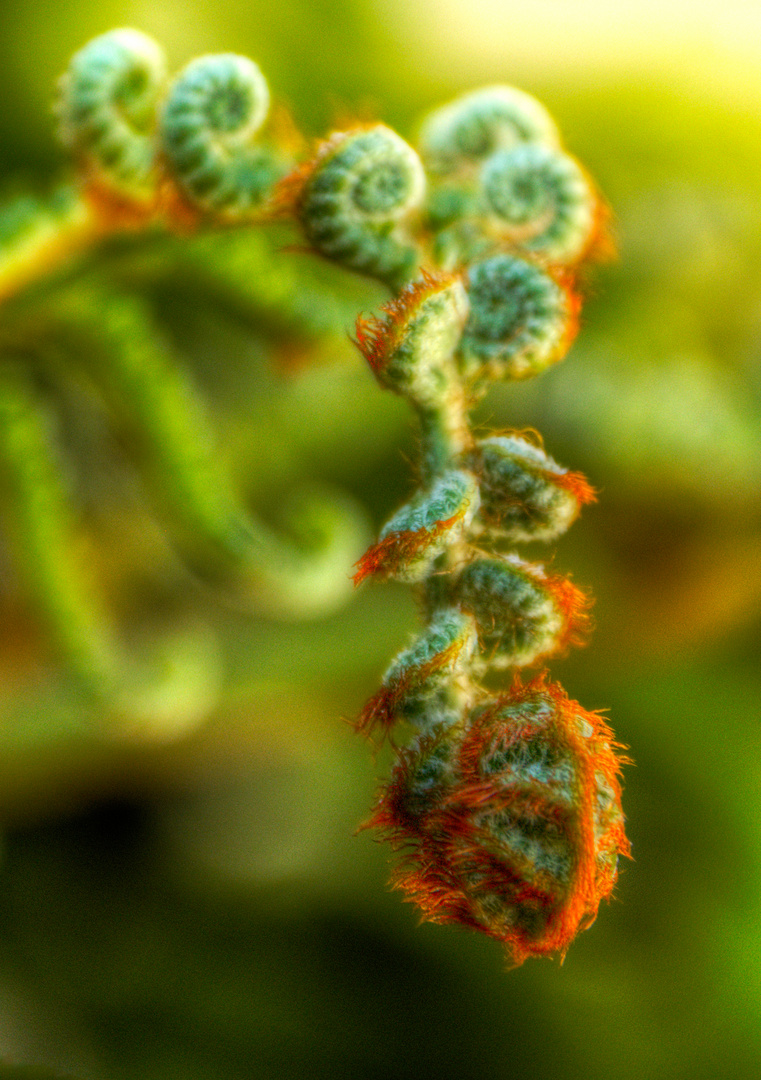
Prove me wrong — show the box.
[0,356,218,729]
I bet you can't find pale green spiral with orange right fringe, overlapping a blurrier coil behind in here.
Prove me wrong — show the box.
[480,144,598,264]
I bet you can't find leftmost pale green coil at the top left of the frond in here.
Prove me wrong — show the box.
[57,29,166,200]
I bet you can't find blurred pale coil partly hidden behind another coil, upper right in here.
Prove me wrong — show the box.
[420,85,558,175]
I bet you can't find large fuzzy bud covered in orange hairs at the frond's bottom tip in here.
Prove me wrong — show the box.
[368,677,628,963]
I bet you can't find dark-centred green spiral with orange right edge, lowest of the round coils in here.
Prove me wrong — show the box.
[460,253,575,379]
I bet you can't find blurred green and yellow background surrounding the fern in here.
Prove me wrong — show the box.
[0,0,761,1080]
